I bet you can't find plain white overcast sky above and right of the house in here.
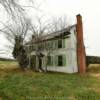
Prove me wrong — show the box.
[0,0,100,56]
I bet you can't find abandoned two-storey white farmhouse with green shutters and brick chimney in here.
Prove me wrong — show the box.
[24,14,86,73]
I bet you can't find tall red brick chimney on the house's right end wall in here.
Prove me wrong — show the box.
[76,14,86,73]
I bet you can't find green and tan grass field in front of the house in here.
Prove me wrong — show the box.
[0,61,100,100]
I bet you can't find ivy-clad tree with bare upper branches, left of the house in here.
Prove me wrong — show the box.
[0,0,43,69]
